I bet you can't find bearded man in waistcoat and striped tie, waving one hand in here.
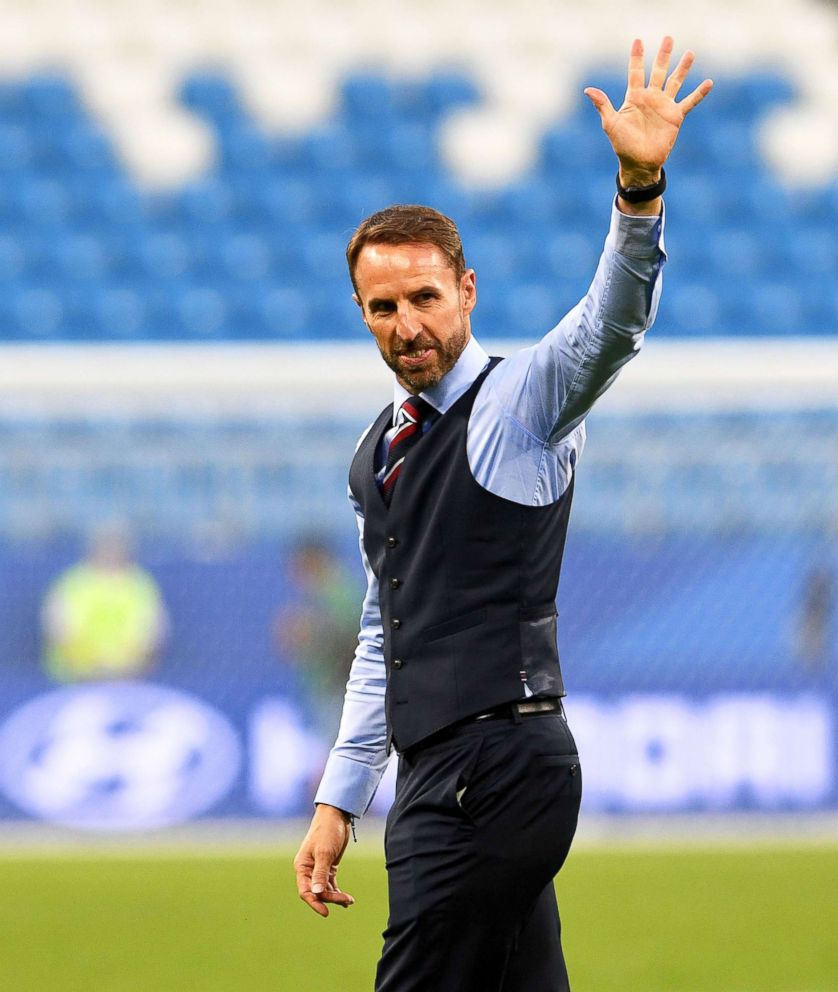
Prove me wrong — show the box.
[295,37,712,992]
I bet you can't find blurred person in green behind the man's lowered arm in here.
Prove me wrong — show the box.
[272,537,358,740]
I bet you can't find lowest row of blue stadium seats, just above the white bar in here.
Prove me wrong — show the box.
[0,275,838,341]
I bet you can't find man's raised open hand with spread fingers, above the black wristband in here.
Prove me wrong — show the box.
[585,35,713,186]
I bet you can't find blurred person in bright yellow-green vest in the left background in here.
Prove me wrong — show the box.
[42,525,169,682]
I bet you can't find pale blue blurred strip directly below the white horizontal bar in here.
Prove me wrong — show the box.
[0,409,838,539]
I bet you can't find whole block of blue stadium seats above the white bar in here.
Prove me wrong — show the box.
[0,72,838,341]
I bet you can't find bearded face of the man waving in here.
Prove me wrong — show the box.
[355,244,477,393]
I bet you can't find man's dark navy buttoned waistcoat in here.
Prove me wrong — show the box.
[349,359,573,751]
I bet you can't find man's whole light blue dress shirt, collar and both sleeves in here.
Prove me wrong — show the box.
[315,203,666,816]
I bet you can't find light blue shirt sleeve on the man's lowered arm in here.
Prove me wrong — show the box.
[314,493,388,816]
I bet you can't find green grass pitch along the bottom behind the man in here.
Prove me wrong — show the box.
[0,843,838,992]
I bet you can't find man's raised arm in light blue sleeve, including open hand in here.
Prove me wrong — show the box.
[469,37,713,504]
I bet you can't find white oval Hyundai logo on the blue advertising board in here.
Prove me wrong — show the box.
[0,682,242,830]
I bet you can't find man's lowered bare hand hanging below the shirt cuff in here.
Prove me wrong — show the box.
[294,803,355,916]
